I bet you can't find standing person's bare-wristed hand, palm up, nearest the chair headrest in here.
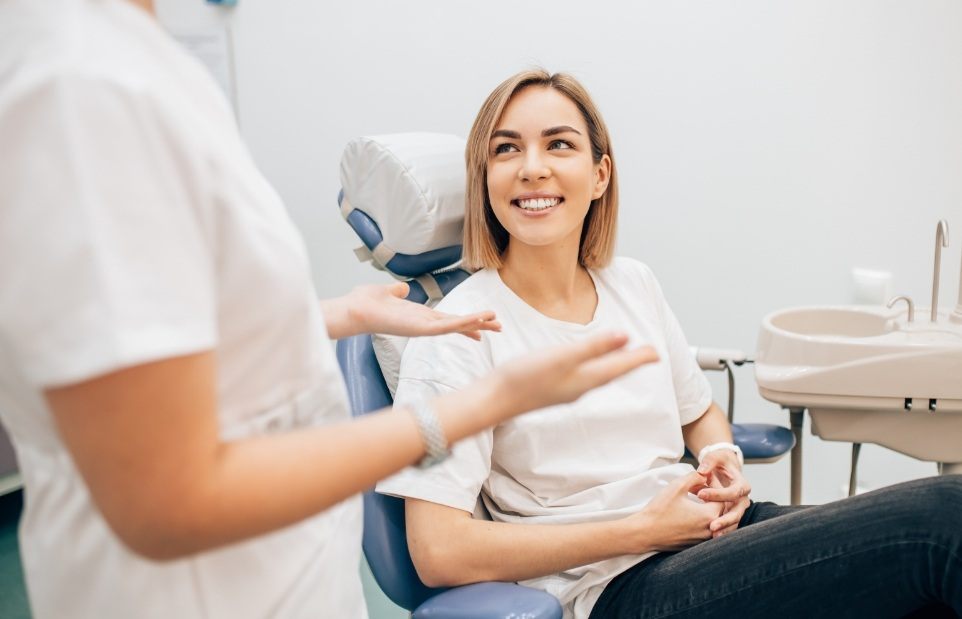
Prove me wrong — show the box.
[321,282,501,340]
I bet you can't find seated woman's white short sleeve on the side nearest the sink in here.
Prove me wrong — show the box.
[634,262,712,425]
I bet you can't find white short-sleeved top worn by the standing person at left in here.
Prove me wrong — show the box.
[0,0,366,619]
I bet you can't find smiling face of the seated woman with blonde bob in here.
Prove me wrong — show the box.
[487,86,611,253]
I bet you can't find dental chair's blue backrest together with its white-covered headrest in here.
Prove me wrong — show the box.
[337,133,480,610]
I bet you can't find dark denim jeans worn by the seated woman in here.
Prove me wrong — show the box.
[591,475,962,619]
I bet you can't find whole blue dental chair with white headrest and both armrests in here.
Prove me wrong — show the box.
[337,133,795,619]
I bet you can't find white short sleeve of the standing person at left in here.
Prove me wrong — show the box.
[0,77,216,388]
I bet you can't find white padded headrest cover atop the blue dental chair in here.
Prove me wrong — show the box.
[341,133,465,254]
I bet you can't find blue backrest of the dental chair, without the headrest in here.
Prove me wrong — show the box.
[337,335,444,610]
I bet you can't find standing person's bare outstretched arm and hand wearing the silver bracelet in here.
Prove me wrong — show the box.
[45,335,657,560]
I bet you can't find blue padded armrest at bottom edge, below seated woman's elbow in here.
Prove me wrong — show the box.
[412,582,561,619]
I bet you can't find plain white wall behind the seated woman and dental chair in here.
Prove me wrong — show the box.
[157,0,962,502]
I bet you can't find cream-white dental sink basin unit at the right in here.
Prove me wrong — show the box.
[755,306,962,469]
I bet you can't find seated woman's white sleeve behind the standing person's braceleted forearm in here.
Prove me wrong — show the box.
[377,322,494,512]
